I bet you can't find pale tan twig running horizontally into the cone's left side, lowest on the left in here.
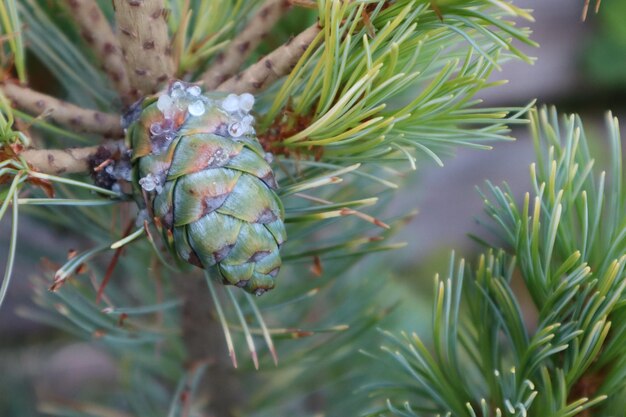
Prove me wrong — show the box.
[19,141,124,175]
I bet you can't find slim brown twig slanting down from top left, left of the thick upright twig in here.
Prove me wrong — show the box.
[64,0,134,104]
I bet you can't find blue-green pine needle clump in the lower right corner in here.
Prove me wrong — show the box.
[383,108,626,417]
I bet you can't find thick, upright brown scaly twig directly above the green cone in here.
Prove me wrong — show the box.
[113,0,174,95]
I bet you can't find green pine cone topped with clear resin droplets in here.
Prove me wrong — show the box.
[127,81,286,295]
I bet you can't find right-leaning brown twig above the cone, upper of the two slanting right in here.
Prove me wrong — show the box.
[201,0,290,90]
